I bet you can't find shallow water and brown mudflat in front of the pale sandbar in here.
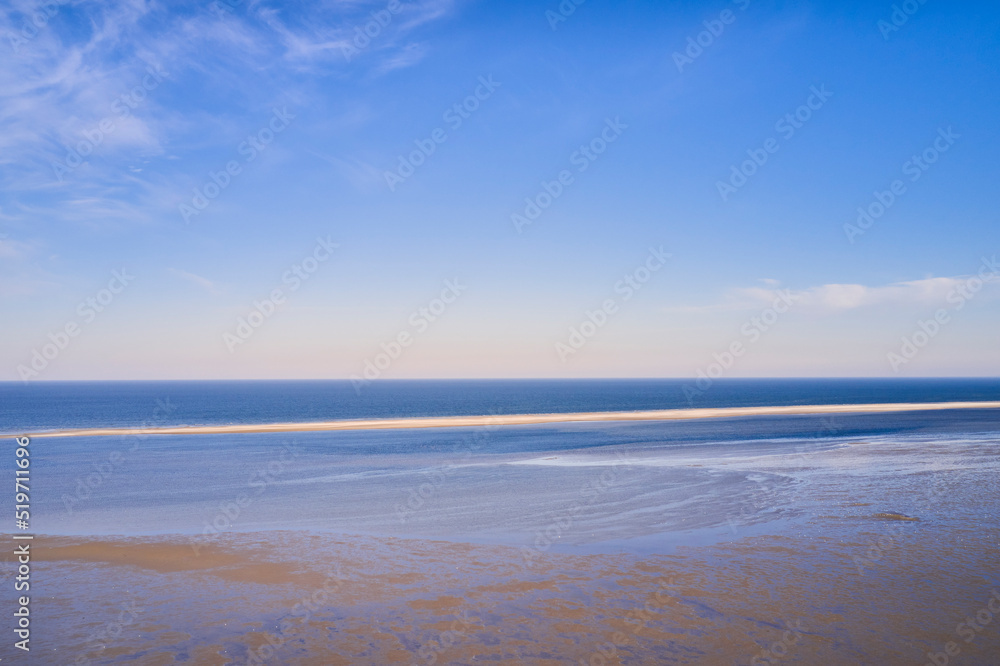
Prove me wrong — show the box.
[0,396,1000,665]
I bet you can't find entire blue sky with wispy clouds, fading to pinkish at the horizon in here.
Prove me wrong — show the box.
[0,0,1000,381]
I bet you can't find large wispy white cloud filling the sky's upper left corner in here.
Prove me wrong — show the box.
[0,0,453,231]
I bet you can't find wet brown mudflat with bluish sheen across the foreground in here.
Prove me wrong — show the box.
[7,520,1000,664]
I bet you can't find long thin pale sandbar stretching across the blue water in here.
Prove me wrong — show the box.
[15,401,1000,438]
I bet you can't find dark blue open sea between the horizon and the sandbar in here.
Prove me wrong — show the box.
[0,379,1000,433]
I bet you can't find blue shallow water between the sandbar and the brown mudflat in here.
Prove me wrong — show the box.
[13,410,1000,551]
